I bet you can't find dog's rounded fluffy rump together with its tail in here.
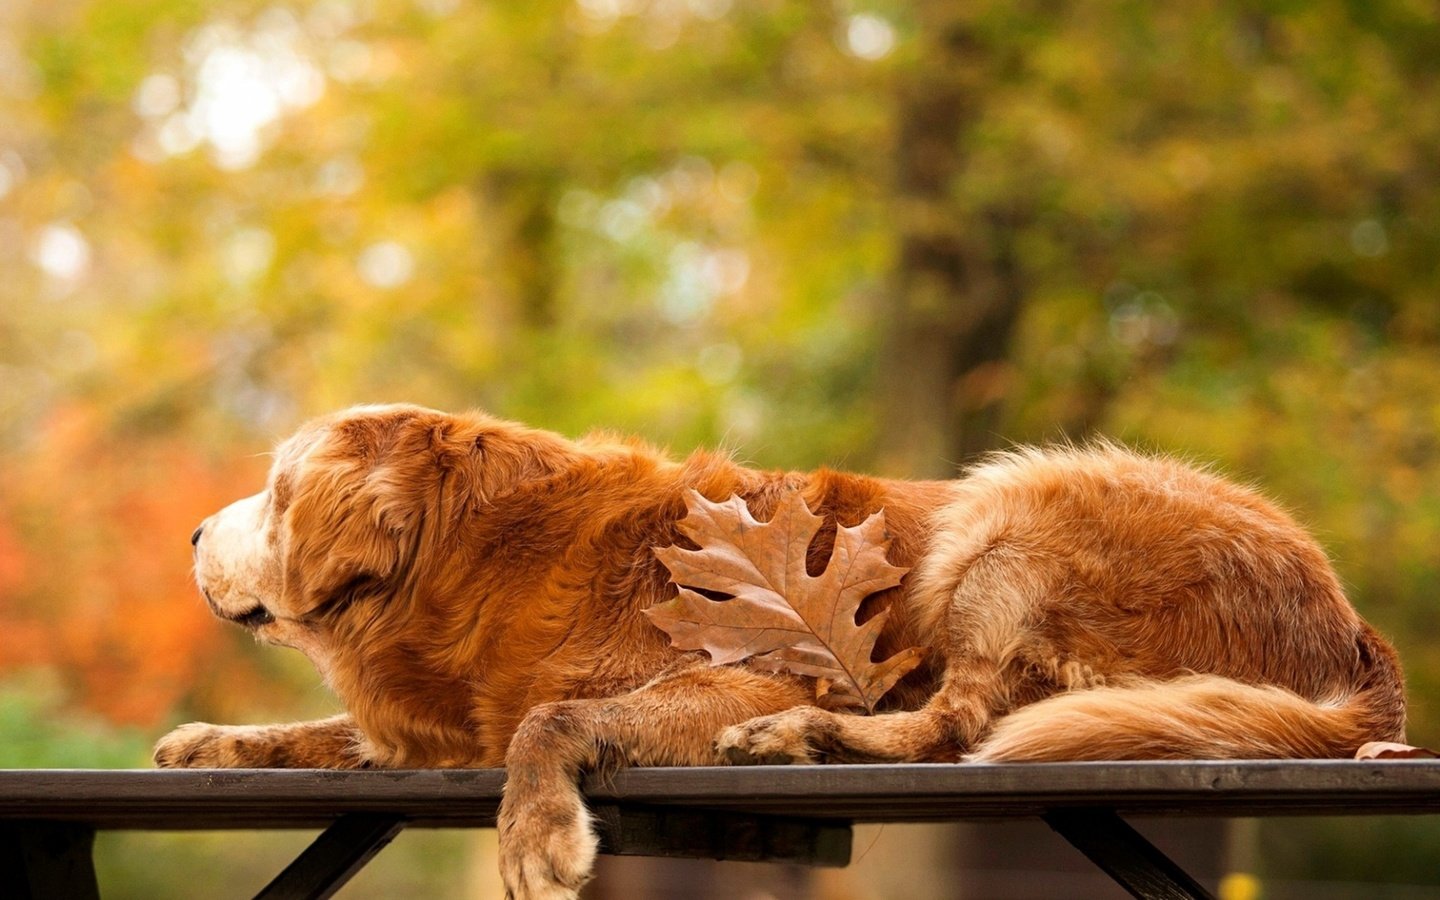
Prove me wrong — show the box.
[916,445,1404,760]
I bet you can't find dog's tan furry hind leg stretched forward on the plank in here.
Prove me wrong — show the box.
[716,544,1063,763]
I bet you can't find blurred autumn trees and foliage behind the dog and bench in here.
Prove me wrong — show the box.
[0,0,1440,899]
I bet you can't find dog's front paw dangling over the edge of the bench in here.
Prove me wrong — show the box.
[500,772,599,900]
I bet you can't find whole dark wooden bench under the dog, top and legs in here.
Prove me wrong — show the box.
[0,760,1440,900]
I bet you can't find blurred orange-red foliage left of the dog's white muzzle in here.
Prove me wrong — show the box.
[0,408,272,726]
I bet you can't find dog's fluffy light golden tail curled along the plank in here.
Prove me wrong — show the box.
[968,625,1405,762]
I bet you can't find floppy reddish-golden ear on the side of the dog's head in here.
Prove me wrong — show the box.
[281,412,436,618]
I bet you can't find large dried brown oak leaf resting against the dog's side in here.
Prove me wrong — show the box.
[645,491,924,713]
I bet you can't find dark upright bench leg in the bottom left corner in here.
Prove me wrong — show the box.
[0,822,99,900]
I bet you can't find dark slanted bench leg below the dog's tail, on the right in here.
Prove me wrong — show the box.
[1044,809,1212,900]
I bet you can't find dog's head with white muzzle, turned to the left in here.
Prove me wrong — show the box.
[192,406,566,652]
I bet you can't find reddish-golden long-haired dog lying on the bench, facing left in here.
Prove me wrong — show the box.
[156,406,1405,900]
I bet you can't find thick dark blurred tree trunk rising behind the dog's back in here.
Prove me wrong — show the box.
[878,7,1024,477]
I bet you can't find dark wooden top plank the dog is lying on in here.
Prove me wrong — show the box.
[0,759,1440,829]
